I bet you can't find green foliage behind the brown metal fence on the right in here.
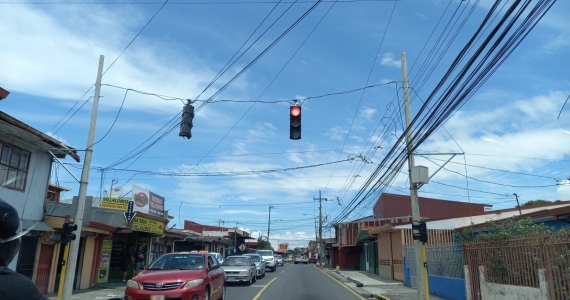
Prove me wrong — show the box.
[455,218,552,243]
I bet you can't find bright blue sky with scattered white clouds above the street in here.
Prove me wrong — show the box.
[0,0,570,248]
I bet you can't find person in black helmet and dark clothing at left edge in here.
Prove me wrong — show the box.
[0,199,48,300]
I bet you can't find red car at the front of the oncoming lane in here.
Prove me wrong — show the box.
[125,252,226,300]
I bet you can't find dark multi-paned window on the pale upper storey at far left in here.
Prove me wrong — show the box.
[0,141,30,191]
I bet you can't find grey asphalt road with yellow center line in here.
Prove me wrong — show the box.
[226,264,365,300]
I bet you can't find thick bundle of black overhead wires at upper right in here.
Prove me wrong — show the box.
[327,0,556,226]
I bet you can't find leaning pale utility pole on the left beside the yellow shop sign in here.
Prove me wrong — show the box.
[62,55,105,300]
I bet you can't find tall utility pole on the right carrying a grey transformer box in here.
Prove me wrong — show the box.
[402,52,429,300]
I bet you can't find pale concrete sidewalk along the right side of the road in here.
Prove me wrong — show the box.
[325,269,446,300]
